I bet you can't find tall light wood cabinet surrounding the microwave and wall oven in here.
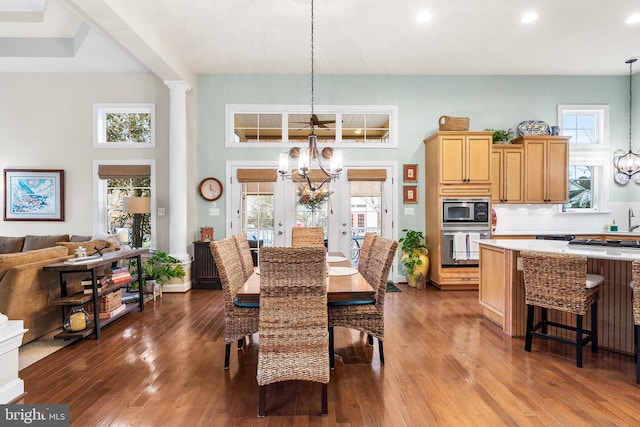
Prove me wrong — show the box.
[424,131,493,291]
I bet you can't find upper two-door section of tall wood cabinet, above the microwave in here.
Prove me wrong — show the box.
[424,132,493,195]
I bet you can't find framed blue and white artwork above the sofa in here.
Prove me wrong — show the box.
[4,169,64,221]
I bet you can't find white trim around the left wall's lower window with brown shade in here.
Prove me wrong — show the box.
[91,159,158,248]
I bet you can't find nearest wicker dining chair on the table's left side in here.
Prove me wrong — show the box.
[211,237,259,369]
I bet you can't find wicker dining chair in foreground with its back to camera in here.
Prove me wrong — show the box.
[257,247,329,417]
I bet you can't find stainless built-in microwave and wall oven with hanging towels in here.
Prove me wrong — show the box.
[440,197,491,267]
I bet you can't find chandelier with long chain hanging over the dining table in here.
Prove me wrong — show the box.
[278,0,342,192]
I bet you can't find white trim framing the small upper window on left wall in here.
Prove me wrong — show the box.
[93,103,156,148]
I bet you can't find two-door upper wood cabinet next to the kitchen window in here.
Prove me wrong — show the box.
[512,135,570,203]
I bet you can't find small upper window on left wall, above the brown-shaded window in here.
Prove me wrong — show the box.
[93,104,155,148]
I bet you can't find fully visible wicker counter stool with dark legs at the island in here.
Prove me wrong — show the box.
[520,251,604,368]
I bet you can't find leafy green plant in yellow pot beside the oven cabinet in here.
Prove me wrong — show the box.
[398,228,429,289]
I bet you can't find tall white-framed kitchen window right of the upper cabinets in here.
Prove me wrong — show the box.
[558,105,610,212]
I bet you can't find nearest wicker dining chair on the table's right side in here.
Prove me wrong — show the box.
[329,236,398,368]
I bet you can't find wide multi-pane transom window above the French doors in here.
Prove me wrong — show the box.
[225,104,398,148]
